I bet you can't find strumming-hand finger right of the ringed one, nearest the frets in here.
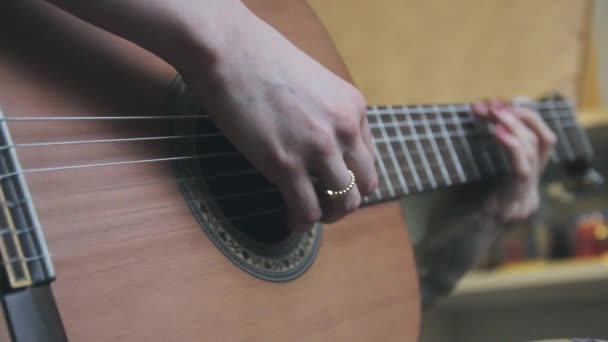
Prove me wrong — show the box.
[344,136,378,196]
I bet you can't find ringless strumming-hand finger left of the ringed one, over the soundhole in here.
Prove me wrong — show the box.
[278,172,322,231]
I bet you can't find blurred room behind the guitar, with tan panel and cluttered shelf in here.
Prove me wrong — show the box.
[310,0,608,342]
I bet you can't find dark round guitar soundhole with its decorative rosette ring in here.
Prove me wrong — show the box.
[164,77,322,281]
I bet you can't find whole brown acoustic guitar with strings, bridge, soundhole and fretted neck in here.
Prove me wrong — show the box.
[0,0,591,341]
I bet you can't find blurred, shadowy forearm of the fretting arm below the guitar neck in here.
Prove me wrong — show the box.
[414,187,507,307]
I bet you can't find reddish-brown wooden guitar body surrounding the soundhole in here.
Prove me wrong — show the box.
[0,1,420,341]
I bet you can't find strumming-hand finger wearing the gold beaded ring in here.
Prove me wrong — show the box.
[313,154,361,223]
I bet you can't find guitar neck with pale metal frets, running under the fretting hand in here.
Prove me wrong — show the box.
[365,95,592,203]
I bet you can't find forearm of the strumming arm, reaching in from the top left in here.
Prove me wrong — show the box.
[42,0,255,68]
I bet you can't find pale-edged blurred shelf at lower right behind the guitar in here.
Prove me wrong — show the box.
[439,255,608,310]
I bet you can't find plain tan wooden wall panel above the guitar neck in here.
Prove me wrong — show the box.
[309,0,590,104]
